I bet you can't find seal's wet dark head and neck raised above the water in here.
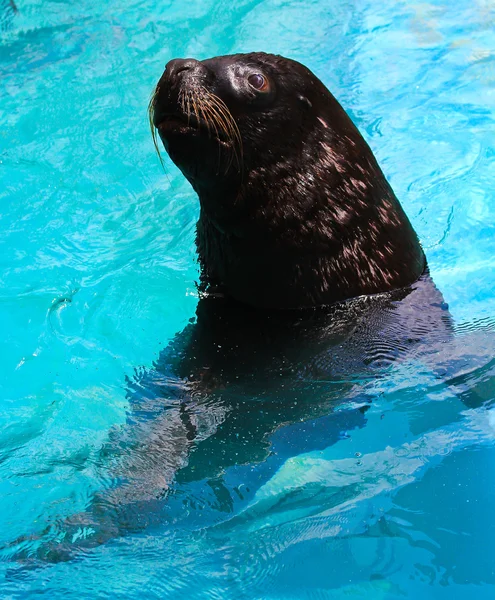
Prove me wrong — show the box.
[150,53,425,308]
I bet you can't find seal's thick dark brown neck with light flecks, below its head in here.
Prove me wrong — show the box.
[197,121,426,308]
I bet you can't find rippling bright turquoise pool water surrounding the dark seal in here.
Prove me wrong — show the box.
[0,0,495,600]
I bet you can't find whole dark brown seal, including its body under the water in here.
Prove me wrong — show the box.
[10,53,462,561]
